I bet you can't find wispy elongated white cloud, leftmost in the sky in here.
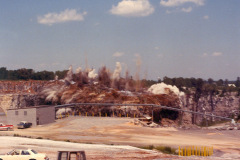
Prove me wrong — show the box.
[38,9,87,25]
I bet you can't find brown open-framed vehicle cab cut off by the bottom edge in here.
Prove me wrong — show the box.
[57,151,86,160]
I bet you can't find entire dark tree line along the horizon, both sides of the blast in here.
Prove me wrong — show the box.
[0,67,240,93]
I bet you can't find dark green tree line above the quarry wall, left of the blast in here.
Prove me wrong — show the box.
[0,67,68,80]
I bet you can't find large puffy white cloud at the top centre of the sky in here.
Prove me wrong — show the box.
[110,0,154,17]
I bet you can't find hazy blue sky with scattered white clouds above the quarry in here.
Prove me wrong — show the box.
[0,0,240,80]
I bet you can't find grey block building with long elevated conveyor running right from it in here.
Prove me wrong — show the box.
[7,103,232,126]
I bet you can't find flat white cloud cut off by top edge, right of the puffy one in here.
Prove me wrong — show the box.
[160,0,204,7]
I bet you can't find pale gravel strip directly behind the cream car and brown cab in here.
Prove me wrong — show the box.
[0,136,177,160]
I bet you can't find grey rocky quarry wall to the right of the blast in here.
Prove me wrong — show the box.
[182,93,240,125]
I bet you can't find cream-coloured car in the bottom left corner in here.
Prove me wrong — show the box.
[0,149,49,160]
